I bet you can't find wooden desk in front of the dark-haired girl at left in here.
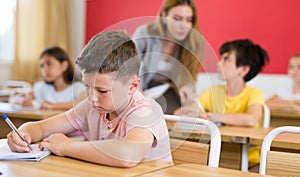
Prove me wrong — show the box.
[0,102,65,138]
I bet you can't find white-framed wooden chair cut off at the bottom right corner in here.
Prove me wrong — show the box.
[259,126,300,176]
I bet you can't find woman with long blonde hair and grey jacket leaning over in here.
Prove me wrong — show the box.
[133,0,204,114]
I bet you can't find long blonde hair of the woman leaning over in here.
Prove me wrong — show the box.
[147,0,204,80]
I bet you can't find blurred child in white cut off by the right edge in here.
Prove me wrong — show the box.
[266,53,300,111]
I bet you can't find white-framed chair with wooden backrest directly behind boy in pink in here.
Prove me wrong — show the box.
[165,115,221,167]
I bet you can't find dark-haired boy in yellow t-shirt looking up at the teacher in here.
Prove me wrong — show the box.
[174,40,268,167]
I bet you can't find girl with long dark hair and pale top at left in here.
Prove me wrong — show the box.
[13,46,86,109]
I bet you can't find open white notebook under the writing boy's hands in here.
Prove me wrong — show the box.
[0,141,51,161]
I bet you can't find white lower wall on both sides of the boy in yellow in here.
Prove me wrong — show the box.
[197,73,292,99]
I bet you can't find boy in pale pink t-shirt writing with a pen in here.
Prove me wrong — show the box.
[7,32,172,167]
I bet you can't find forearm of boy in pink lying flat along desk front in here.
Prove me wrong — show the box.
[64,139,151,167]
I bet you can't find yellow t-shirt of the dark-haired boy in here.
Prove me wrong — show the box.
[198,85,265,163]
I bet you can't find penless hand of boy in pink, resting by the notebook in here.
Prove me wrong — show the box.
[39,133,72,156]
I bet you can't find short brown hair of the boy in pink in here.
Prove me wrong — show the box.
[75,31,140,82]
